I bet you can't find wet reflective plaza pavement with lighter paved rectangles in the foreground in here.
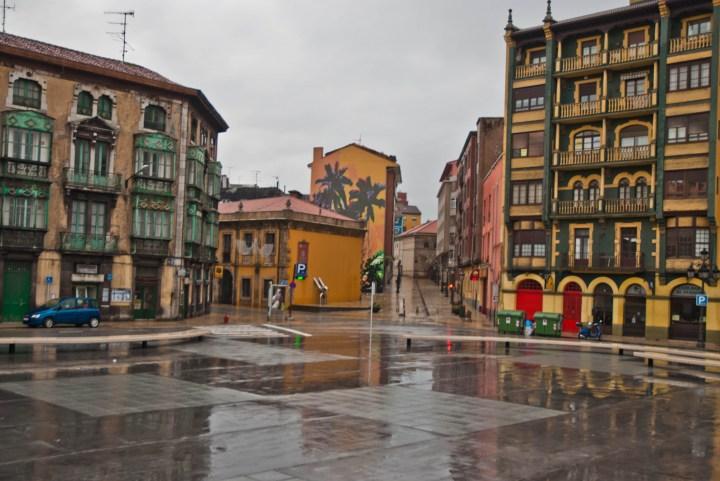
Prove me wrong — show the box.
[0,318,720,481]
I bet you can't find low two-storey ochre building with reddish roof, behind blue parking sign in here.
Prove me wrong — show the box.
[217,196,366,307]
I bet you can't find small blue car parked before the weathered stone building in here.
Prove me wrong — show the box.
[23,297,100,328]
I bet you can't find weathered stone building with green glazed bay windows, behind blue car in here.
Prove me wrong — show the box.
[0,33,227,321]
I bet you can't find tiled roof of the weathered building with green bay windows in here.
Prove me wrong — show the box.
[0,32,228,132]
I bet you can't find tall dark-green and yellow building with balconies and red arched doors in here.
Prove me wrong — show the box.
[501,0,720,342]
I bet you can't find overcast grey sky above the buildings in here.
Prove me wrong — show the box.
[7,0,628,219]
